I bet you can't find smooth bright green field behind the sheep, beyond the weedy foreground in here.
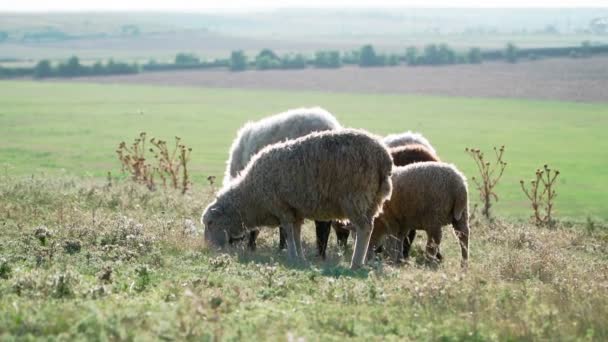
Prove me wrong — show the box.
[0,82,608,219]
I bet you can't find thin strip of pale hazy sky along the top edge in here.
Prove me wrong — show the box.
[0,0,608,11]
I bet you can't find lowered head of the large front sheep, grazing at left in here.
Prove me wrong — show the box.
[201,200,246,247]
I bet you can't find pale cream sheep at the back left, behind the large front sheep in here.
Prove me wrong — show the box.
[223,107,342,254]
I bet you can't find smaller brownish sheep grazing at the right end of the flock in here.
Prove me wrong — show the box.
[369,162,469,266]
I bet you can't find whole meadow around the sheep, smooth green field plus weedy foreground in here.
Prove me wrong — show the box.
[0,81,608,341]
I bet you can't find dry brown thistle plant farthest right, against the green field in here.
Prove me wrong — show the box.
[519,164,559,227]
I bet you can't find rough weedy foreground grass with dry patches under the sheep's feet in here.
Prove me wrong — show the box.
[0,176,608,341]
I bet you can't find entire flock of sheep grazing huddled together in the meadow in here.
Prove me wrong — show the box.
[201,108,469,269]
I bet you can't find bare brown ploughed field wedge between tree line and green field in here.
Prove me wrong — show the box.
[67,56,608,102]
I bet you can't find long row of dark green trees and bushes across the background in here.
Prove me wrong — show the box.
[0,41,608,78]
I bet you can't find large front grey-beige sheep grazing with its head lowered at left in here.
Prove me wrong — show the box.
[201,129,393,269]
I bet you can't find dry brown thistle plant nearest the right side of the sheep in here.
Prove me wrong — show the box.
[465,146,507,219]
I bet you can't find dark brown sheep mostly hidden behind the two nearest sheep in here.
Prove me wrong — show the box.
[326,144,439,257]
